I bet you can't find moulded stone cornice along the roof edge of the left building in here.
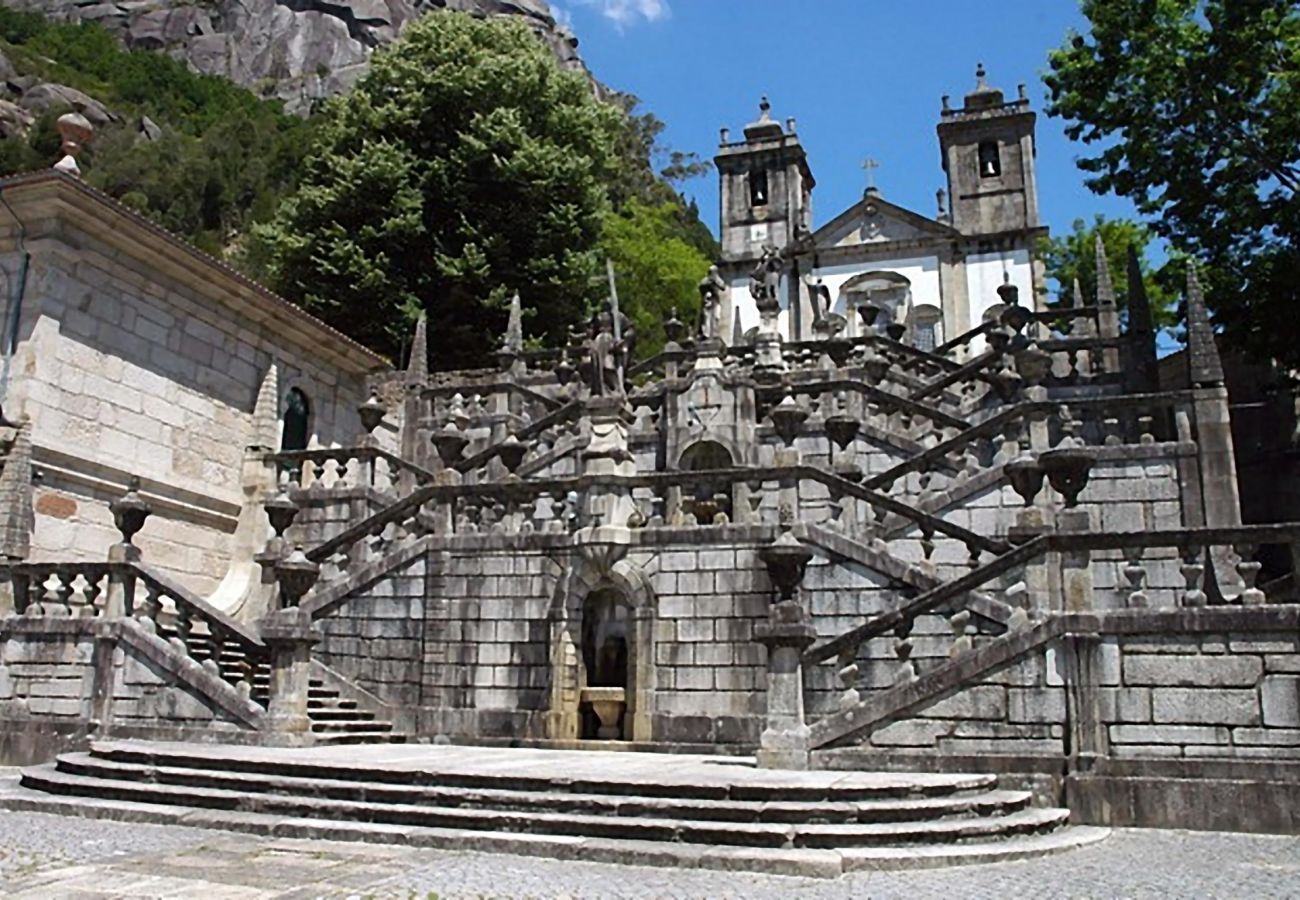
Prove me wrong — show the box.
[0,170,389,375]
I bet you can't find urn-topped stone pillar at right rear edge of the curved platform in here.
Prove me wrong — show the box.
[754,532,816,769]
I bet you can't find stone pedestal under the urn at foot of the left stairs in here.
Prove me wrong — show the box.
[259,606,321,747]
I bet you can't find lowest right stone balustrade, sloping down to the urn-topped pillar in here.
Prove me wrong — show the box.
[801,523,1300,745]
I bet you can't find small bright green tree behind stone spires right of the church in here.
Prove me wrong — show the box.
[1039,216,1178,328]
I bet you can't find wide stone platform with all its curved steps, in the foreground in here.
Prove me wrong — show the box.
[0,741,1106,878]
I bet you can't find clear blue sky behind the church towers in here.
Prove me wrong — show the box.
[553,0,1135,295]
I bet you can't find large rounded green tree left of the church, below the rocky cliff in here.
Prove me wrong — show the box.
[252,13,621,367]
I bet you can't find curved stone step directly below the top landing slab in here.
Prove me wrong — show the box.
[55,753,1031,825]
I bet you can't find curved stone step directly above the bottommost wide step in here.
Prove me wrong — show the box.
[22,766,1069,849]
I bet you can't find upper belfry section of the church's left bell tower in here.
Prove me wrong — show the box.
[714,96,815,263]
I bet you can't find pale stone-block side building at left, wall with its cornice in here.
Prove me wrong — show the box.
[0,176,382,593]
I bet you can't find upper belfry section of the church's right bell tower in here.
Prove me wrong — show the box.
[939,62,1039,235]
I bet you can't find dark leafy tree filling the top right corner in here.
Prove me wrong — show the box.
[1045,0,1300,367]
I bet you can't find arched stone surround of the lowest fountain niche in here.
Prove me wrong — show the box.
[549,555,657,741]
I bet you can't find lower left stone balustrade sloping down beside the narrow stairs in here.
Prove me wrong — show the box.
[3,562,269,706]
